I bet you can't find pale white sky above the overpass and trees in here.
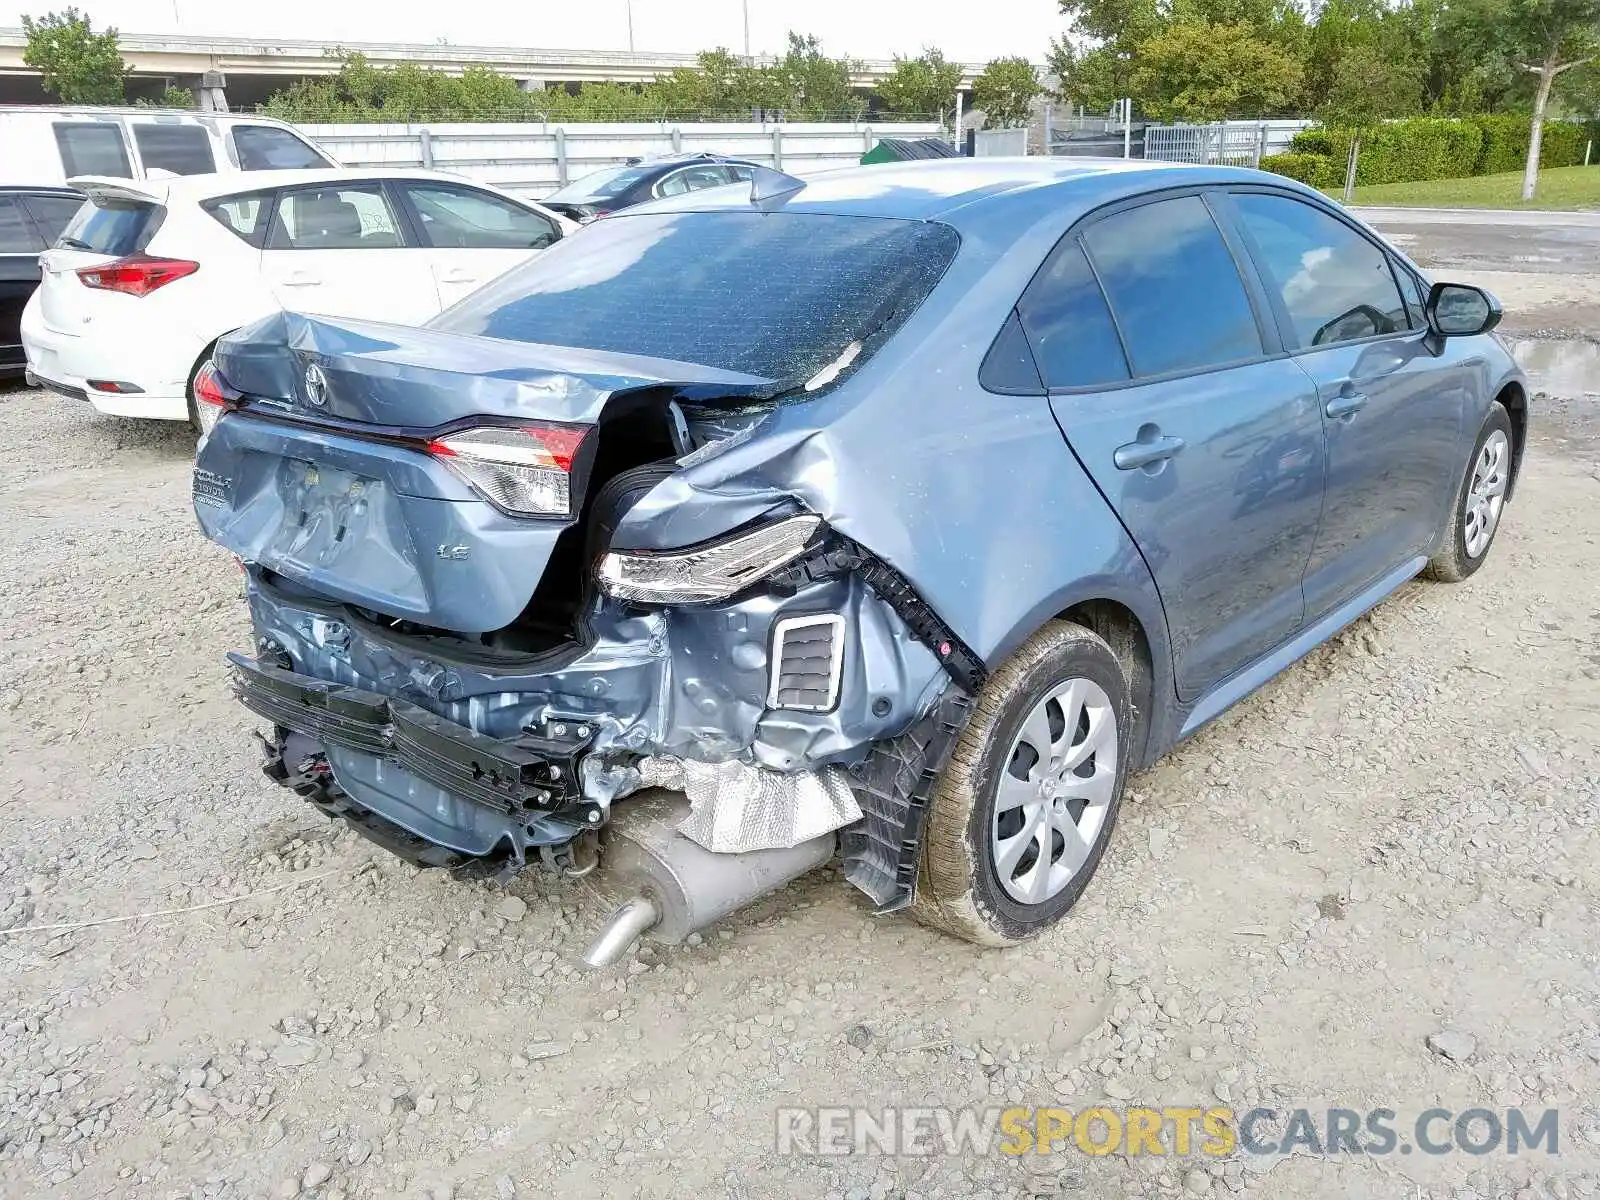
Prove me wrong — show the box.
[0,0,1066,62]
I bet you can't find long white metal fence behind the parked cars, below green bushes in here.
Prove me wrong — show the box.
[301,122,947,197]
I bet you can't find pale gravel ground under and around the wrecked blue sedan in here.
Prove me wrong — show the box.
[0,249,1600,1200]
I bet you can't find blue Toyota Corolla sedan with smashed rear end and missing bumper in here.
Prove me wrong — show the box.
[194,160,1526,962]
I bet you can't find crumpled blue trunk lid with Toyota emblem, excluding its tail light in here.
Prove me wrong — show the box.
[194,314,771,634]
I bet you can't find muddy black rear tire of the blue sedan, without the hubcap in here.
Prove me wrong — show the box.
[912,621,1133,946]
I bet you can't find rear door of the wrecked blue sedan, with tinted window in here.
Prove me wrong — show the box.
[1019,194,1326,699]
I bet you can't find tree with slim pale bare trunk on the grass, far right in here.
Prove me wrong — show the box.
[1445,0,1600,200]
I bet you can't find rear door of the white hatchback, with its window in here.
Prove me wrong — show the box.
[261,181,440,325]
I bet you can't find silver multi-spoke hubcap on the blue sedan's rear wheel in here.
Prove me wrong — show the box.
[989,678,1117,904]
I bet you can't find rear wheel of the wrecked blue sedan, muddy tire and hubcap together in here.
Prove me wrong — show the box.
[912,621,1131,946]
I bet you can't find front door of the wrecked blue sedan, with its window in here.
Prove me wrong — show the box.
[1230,190,1472,618]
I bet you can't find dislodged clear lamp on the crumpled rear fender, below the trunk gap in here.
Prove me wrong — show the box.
[598,515,822,605]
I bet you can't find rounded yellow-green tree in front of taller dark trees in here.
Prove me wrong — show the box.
[1131,21,1301,122]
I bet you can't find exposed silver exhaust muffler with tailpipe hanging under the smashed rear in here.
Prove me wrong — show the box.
[584,789,835,966]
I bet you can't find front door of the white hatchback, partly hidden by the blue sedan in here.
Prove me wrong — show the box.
[392,179,562,309]
